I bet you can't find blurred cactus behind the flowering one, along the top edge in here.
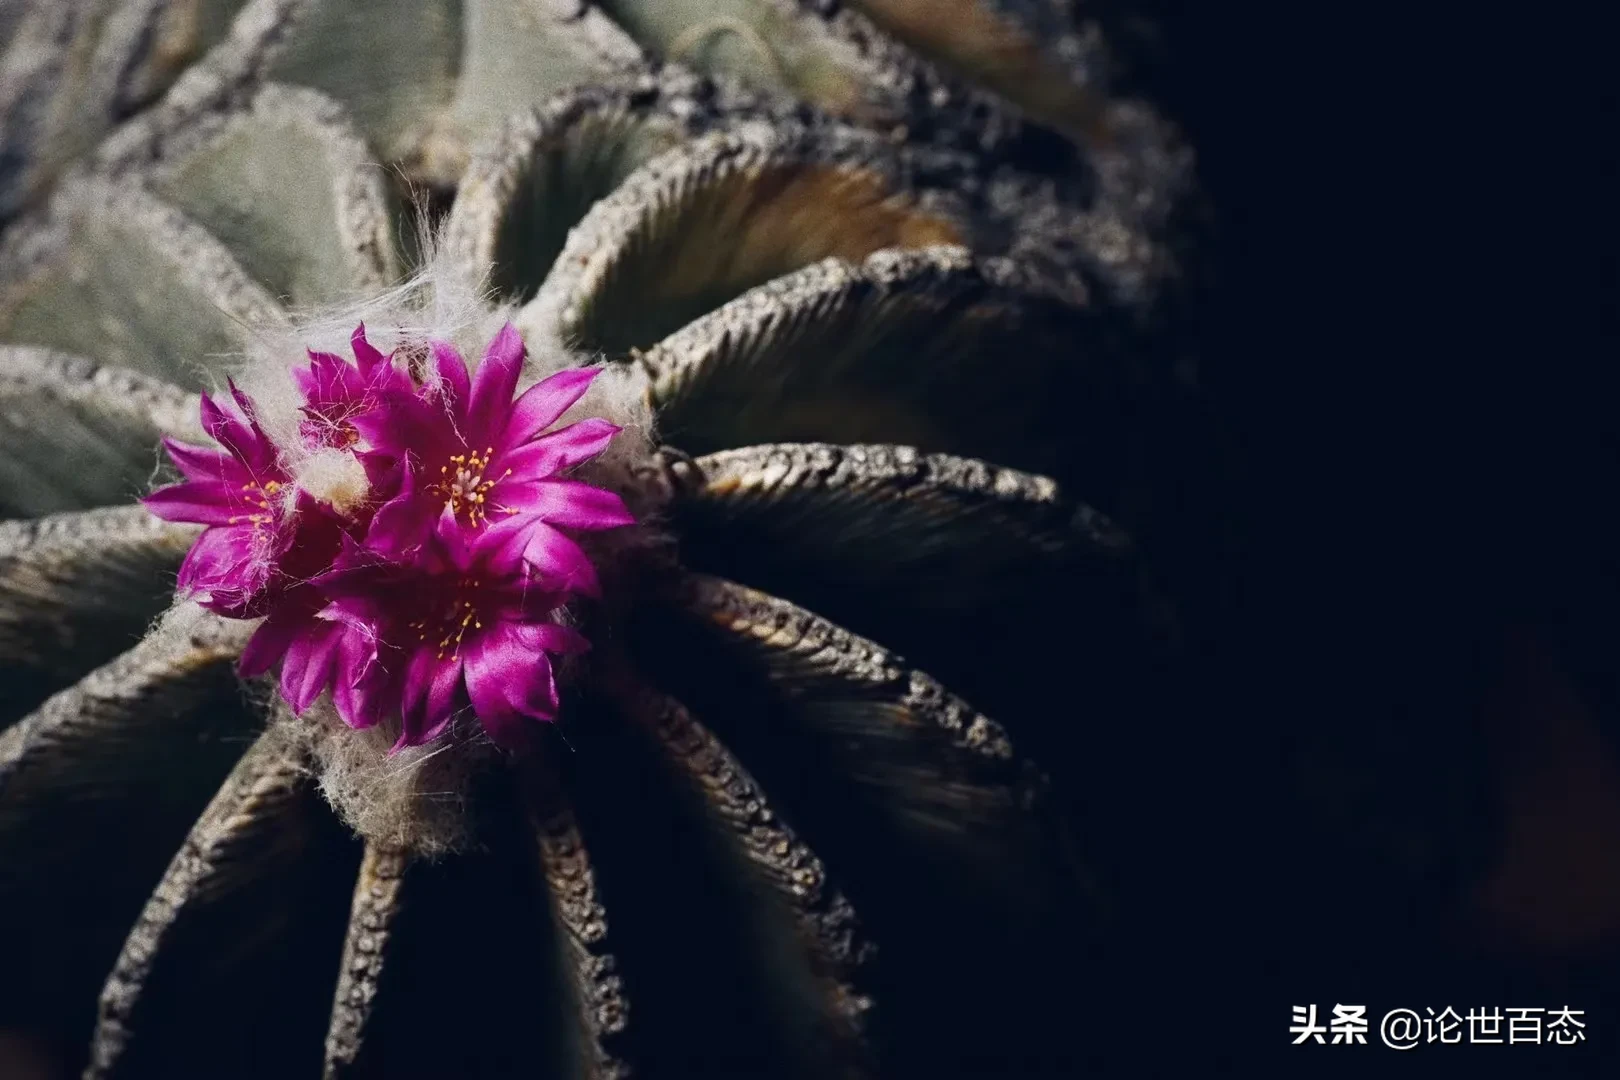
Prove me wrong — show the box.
[0,0,1191,303]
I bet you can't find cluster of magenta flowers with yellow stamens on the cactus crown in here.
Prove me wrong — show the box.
[144,325,633,750]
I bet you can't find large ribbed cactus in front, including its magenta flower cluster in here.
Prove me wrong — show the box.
[0,3,1192,1077]
